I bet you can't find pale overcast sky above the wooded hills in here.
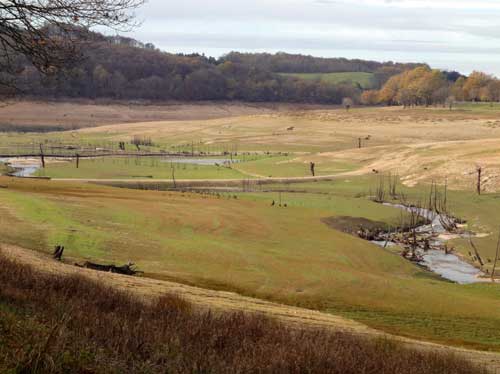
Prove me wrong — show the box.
[120,0,500,76]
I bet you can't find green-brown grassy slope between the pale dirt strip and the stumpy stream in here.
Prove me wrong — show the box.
[0,175,500,350]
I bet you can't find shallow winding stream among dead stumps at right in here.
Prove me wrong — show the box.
[373,203,485,284]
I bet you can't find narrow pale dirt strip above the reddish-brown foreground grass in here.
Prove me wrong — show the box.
[0,244,500,373]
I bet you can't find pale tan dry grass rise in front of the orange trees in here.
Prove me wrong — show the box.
[78,107,500,151]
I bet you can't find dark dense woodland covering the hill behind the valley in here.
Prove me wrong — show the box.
[7,29,419,104]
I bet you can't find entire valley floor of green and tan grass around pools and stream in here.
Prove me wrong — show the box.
[0,104,500,351]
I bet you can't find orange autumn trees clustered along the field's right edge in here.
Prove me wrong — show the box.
[361,66,500,109]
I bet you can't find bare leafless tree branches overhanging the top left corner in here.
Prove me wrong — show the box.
[0,0,146,88]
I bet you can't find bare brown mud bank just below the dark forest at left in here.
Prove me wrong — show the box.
[0,100,330,131]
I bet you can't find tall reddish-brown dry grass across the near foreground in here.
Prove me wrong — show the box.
[0,253,486,374]
